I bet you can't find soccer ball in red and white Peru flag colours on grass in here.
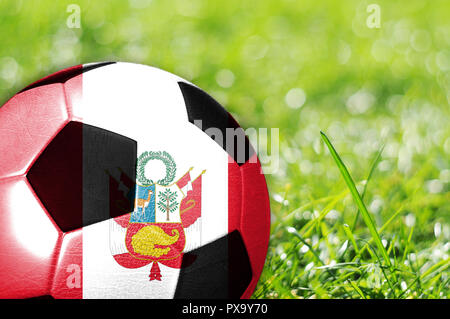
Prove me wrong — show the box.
[0,62,270,298]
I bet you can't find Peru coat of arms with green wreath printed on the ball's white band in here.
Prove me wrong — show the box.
[110,151,205,281]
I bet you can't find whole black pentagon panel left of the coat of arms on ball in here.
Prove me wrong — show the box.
[27,122,137,232]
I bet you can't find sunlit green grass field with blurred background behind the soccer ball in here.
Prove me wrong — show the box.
[0,0,450,298]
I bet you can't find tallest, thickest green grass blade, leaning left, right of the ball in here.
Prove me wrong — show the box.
[320,131,395,278]
